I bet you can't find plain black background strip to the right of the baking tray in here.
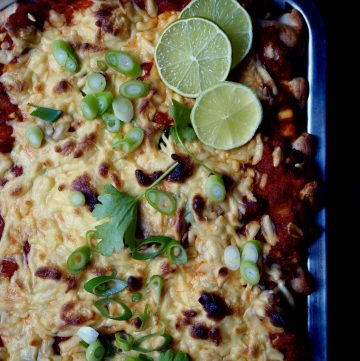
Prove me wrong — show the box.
[309,0,360,361]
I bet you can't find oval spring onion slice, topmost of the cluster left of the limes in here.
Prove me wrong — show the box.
[105,51,141,78]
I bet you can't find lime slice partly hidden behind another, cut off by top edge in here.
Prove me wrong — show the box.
[180,0,253,68]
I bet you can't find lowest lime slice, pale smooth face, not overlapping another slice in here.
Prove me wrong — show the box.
[191,82,262,150]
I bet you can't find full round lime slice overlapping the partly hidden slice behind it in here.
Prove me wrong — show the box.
[155,18,232,98]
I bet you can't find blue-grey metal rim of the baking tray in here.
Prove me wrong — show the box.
[0,0,328,361]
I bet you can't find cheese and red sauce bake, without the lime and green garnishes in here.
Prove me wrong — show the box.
[0,0,320,361]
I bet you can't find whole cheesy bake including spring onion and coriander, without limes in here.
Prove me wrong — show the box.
[0,0,320,361]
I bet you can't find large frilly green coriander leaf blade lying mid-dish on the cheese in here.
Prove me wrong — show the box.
[92,184,138,256]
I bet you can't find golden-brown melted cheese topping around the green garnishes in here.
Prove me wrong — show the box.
[0,0,283,361]
